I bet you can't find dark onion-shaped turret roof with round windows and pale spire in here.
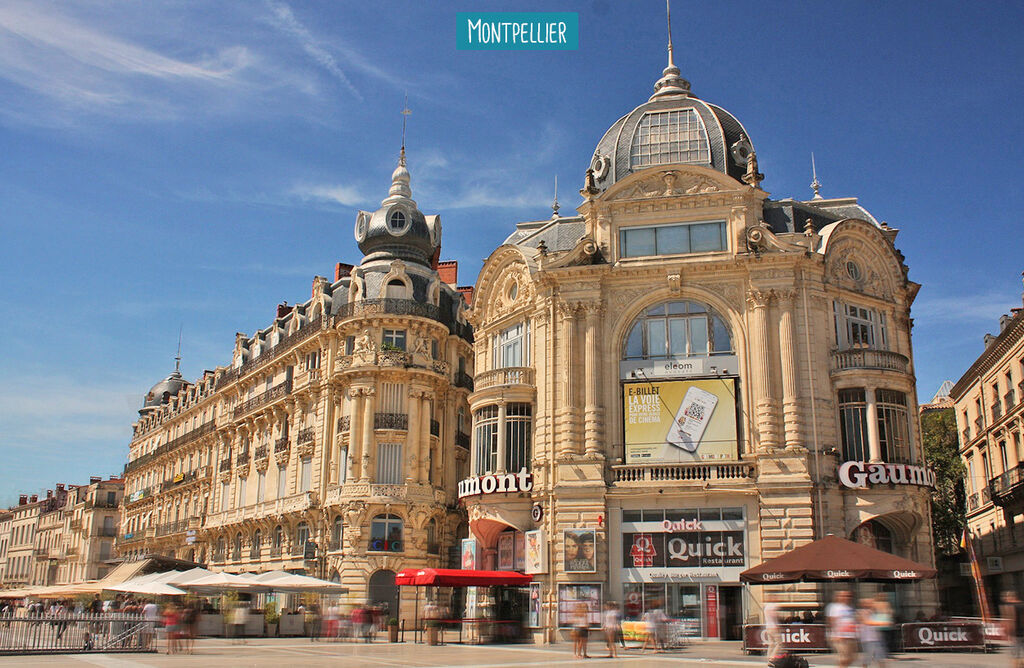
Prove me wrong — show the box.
[355,148,440,266]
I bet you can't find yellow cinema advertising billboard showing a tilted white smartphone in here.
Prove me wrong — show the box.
[623,378,739,464]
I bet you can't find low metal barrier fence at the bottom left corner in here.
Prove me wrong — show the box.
[0,614,156,655]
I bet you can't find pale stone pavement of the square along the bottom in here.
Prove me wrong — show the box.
[0,638,1010,668]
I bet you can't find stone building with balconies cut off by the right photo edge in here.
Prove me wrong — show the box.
[949,284,1024,610]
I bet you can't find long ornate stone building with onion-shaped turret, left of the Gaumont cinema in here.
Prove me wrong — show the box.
[119,149,472,610]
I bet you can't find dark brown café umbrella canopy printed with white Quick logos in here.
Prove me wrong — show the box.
[739,534,936,584]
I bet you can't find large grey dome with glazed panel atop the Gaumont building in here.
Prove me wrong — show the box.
[590,58,754,191]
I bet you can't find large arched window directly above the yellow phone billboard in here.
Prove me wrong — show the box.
[623,301,733,360]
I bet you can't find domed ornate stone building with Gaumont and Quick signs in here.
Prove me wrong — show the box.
[460,48,936,638]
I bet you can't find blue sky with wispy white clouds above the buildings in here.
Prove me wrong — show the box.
[0,0,1024,504]
